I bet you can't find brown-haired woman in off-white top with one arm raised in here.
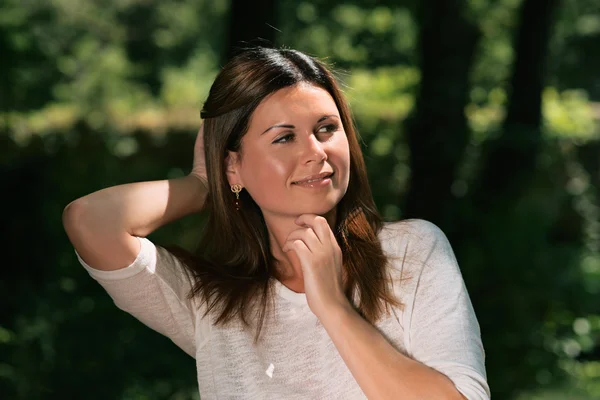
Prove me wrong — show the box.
[63,48,490,400]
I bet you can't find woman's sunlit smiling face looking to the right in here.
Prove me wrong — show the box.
[228,83,350,218]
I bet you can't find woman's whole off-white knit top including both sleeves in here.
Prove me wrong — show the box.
[76,220,490,400]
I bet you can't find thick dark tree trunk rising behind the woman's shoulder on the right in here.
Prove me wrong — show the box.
[403,0,480,223]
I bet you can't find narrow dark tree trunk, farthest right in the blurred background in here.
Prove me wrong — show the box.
[477,0,559,203]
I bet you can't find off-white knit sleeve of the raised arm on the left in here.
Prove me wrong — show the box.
[75,238,208,357]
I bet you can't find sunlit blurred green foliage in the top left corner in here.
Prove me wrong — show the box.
[0,0,227,115]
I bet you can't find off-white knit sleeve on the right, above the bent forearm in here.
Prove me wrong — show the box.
[404,220,490,400]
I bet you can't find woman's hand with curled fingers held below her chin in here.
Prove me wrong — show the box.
[282,214,349,319]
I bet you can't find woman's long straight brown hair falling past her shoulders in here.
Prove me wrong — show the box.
[170,47,400,339]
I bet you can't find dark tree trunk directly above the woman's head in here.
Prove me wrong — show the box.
[224,0,277,61]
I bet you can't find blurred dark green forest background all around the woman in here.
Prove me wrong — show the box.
[0,0,600,400]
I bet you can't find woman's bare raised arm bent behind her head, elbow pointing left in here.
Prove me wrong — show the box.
[63,128,208,271]
